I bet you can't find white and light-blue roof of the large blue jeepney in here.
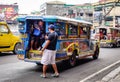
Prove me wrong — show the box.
[18,15,92,25]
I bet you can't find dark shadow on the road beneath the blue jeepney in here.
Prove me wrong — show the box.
[29,58,93,73]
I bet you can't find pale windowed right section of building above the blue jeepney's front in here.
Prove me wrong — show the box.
[71,3,93,22]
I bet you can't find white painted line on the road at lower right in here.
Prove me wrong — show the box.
[80,60,120,82]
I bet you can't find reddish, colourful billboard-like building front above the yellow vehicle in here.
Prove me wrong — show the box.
[0,3,18,23]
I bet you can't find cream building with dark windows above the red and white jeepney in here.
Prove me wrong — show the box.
[93,0,120,27]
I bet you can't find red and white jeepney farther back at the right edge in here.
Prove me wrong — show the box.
[95,26,120,48]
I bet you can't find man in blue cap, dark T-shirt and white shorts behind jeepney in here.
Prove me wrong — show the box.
[41,24,59,78]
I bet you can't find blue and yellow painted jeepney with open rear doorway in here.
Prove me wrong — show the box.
[18,16,99,66]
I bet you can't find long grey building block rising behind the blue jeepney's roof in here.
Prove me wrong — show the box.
[40,1,93,22]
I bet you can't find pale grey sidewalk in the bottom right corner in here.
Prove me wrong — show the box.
[96,66,120,82]
